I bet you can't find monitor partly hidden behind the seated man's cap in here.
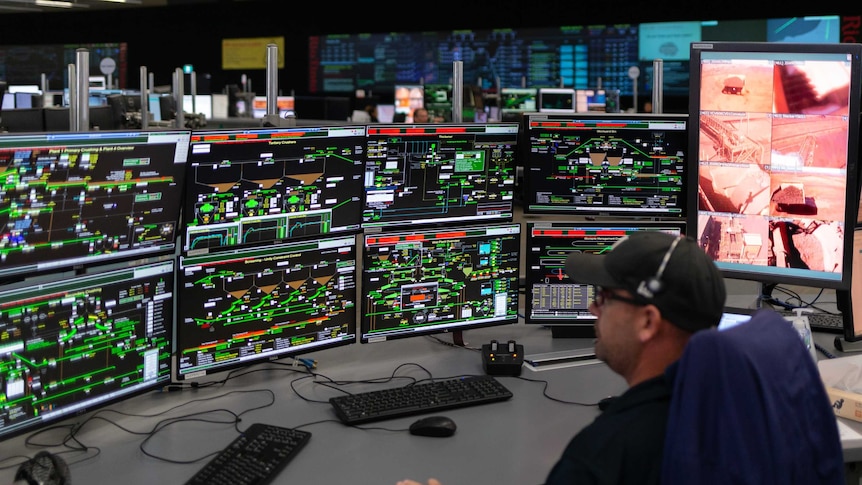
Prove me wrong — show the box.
[524,220,685,338]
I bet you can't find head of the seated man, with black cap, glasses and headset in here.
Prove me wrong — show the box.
[565,231,726,384]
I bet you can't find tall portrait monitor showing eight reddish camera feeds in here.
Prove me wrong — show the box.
[688,42,862,291]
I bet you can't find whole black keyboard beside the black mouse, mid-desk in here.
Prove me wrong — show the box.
[329,375,512,424]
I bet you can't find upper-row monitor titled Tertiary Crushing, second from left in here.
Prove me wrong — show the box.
[182,125,366,254]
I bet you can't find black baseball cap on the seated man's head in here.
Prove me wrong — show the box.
[566,231,727,332]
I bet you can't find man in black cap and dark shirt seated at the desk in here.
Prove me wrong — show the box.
[398,231,726,485]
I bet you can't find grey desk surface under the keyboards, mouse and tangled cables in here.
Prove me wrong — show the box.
[0,323,862,485]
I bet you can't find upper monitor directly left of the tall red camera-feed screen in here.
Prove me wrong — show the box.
[524,113,689,218]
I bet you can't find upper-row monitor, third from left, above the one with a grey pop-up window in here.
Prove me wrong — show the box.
[362,122,519,231]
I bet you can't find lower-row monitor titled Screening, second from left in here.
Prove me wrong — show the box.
[176,234,359,380]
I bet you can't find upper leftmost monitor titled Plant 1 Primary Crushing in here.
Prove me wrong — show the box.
[0,130,191,278]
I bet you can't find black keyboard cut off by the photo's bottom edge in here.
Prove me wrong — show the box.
[186,423,311,485]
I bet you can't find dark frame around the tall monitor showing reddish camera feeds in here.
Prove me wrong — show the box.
[687,41,862,296]
